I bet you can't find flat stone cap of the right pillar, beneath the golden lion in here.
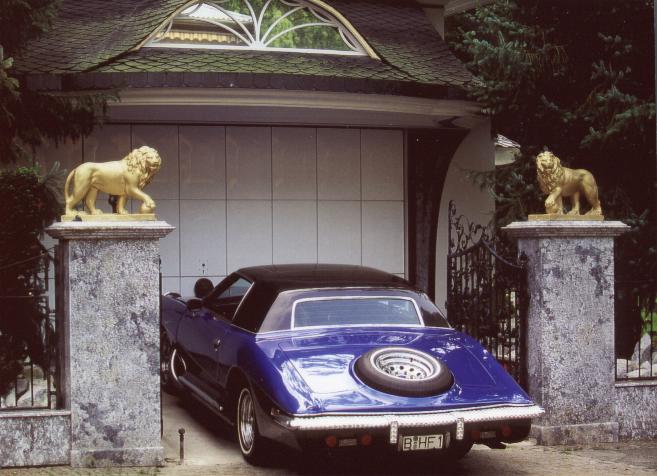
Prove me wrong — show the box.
[502,220,630,238]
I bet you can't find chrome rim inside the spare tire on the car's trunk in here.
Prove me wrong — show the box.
[370,347,441,382]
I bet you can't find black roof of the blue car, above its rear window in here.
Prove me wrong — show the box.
[234,264,416,332]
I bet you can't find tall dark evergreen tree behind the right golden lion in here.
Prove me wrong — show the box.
[447,0,657,354]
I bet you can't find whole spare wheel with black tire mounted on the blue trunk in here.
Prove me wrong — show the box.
[354,347,454,397]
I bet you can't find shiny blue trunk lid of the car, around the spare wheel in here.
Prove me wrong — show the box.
[262,328,531,412]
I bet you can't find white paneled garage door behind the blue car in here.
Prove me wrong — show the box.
[39,124,406,293]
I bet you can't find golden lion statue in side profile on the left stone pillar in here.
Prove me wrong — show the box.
[64,146,162,215]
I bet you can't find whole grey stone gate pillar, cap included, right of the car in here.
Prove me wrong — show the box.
[504,221,629,445]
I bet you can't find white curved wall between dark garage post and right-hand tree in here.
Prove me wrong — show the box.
[436,121,495,311]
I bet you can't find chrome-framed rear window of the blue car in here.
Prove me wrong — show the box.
[292,297,423,328]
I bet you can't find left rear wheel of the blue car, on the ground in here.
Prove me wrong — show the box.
[235,387,267,466]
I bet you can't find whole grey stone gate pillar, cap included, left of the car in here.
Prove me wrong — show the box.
[46,221,173,467]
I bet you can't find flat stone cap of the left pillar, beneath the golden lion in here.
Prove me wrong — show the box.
[46,221,175,240]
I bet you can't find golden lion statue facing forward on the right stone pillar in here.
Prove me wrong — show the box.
[536,151,602,216]
